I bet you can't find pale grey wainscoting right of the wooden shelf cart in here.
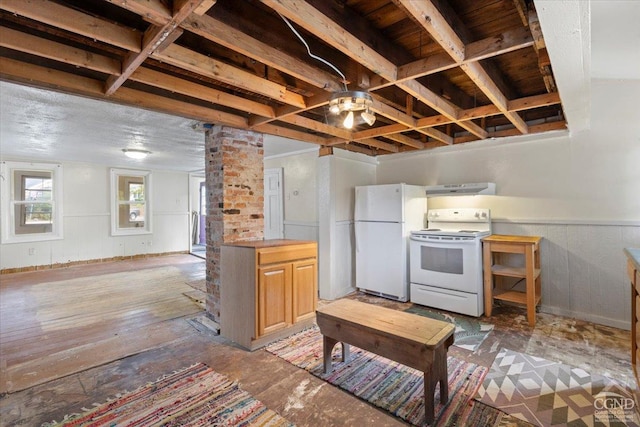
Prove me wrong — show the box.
[493,220,640,329]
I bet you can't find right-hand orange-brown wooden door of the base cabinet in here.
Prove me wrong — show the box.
[293,259,318,323]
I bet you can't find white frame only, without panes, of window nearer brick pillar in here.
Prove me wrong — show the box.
[109,168,153,236]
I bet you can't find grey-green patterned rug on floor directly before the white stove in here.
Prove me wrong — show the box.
[405,305,493,351]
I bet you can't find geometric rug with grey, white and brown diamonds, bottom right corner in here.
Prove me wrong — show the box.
[475,349,640,427]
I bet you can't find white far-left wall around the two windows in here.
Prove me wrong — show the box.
[0,159,189,269]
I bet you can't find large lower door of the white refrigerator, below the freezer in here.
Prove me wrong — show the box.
[355,222,409,301]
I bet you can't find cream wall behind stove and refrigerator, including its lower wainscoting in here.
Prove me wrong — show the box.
[377,80,640,328]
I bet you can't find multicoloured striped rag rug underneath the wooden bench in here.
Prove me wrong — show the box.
[266,327,488,426]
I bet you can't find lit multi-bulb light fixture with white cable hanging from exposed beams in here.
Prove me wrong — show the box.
[280,15,376,129]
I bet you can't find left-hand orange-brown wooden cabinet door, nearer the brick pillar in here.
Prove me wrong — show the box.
[256,263,292,338]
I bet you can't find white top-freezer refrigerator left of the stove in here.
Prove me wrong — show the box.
[354,184,427,302]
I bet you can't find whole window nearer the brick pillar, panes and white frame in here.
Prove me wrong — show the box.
[111,169,151,236]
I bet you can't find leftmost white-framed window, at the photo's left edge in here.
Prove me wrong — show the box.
[0,162,62,243]
